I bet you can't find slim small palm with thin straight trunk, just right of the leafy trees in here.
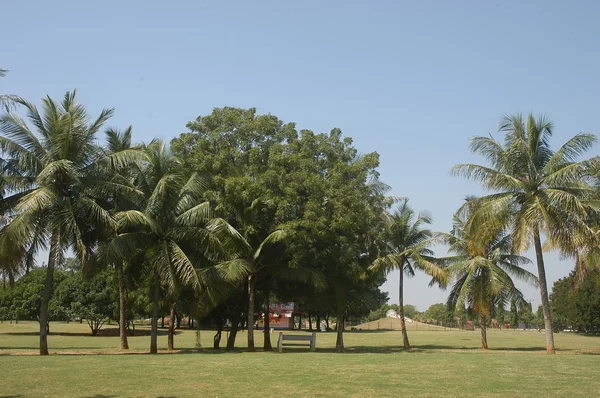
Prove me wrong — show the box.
[369,199,446,350]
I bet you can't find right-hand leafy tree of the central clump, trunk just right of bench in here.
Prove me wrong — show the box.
[272,129,389,351]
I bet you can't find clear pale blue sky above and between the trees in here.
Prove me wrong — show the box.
[0,0,600,310]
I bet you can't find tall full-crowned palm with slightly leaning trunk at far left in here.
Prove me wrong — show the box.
[0,91,136,355]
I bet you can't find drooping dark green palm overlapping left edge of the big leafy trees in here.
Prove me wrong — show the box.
[101,140,217,353]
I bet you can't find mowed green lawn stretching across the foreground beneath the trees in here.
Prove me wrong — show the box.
[0,322,600,397]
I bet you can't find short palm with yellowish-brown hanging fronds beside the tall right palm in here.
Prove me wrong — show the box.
[440,202,537,349]
